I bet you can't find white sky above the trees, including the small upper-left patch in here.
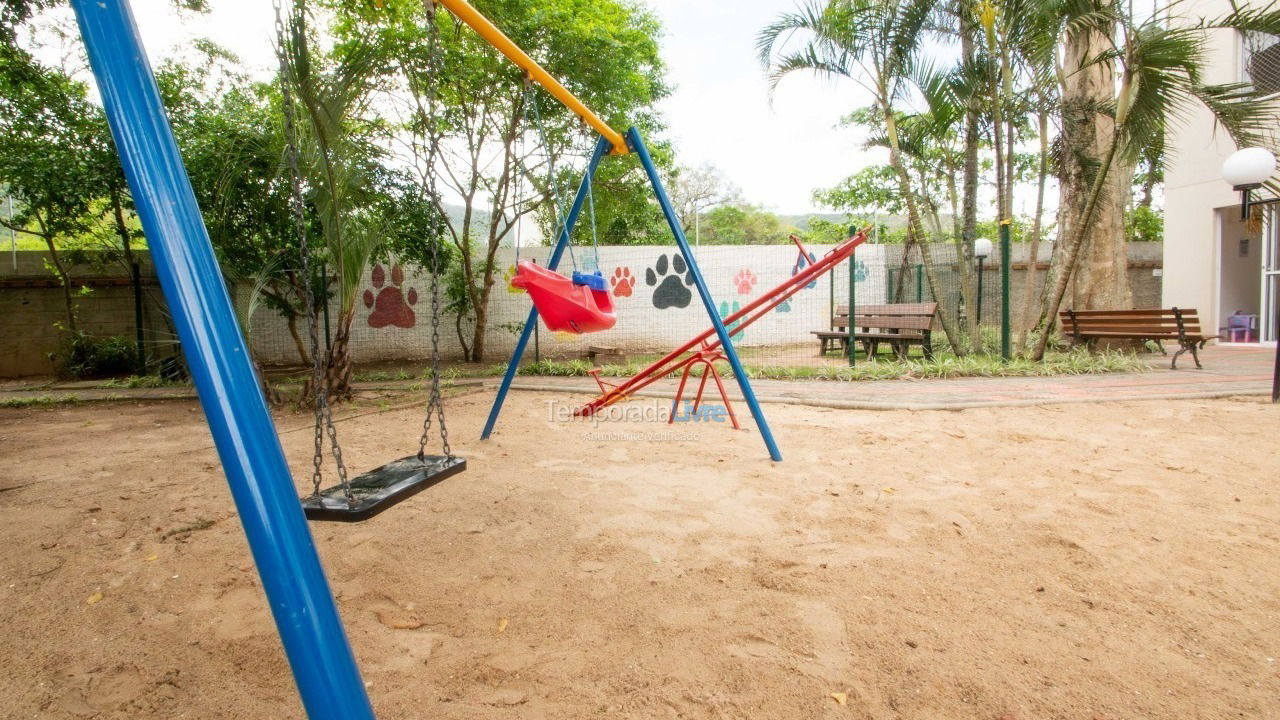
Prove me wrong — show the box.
[115,0,876,214]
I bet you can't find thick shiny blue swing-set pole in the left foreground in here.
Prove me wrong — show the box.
[72,0,374,720]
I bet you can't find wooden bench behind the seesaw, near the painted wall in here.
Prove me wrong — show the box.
[813,302,938,360]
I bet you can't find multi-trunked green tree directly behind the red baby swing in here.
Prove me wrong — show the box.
[335,0,668,361]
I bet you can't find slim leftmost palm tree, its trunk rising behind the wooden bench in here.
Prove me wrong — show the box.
[756,0,964,354]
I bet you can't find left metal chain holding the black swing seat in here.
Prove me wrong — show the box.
[273,0,353,505]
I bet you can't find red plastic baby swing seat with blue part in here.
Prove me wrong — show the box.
[511,260,618,334]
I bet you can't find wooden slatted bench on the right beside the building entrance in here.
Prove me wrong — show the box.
[1060,307,1217,370]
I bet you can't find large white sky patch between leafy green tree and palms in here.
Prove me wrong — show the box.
[648,0,874,214]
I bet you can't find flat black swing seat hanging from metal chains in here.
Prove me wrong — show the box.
[302,455,467,523]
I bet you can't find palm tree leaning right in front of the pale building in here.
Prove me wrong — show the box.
[1032,0,1280,360]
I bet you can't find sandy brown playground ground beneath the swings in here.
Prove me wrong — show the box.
[0,392,1280,720]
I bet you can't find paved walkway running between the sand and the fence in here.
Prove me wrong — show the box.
[0,346,1275,410]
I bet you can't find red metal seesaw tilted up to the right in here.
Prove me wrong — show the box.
[573,225,870,420]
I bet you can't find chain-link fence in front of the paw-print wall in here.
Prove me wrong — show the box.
[225,238,1160,368]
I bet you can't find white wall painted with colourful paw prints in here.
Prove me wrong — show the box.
[239,243,884,365]
